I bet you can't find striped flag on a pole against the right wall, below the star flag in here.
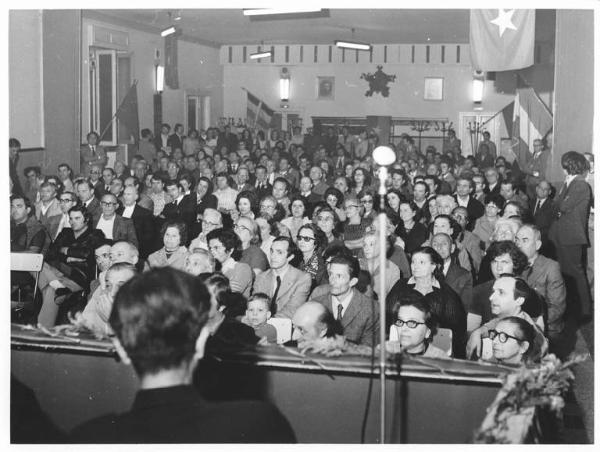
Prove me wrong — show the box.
[511,81,552,168]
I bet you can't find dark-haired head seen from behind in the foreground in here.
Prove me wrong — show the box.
[109,267,210,376]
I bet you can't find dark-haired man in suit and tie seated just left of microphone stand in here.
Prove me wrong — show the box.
[313,256,379,347]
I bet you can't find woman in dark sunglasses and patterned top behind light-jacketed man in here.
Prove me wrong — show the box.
[296,223,327,290]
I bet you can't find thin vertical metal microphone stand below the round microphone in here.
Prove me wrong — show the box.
[378,166,388,444]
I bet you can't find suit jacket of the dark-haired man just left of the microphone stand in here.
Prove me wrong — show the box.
[312,289,379,347]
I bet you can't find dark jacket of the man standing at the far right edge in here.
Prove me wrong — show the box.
[549,175,592,246]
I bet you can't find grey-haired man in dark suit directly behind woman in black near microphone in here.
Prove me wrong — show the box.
[431,233,473,311]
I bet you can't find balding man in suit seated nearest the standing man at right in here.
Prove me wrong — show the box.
[515,224,567,339]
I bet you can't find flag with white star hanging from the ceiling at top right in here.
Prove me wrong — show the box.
[471,9,535,72]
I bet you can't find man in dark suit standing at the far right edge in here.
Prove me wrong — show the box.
[548,151,592,321]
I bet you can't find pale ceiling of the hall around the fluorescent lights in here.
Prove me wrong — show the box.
[83,9,476,47]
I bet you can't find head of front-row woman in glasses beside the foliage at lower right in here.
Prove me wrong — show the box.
[488,317,539,364]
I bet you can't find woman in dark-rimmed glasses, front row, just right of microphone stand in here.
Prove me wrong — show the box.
[386,290,448,359]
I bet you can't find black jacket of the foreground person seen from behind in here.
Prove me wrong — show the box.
[71,385,296,443]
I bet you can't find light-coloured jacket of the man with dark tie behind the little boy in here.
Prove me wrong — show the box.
[253,265,312,319]
